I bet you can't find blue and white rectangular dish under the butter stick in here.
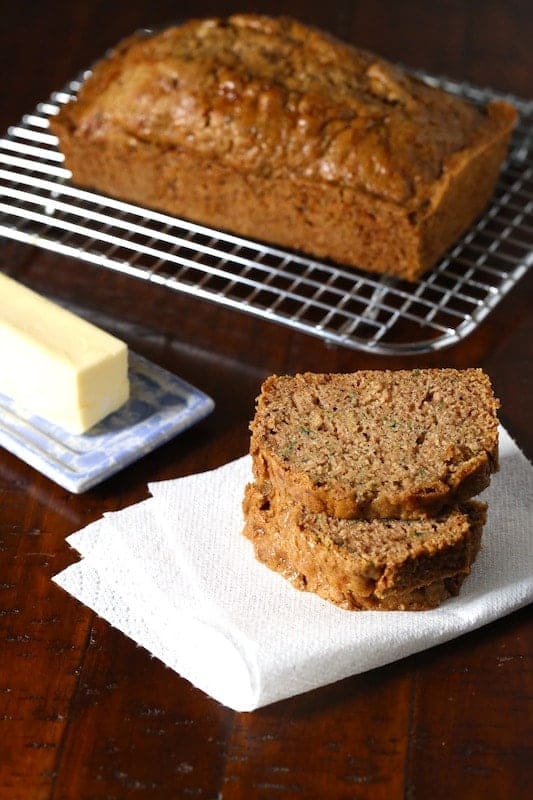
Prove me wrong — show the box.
[0,352,215,494]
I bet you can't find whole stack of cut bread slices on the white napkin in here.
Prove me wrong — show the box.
[244,369,499,610]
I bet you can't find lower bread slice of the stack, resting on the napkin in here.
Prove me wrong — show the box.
[244,483,486,611]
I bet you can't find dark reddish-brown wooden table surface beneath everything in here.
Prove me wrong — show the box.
[0,0,533,800]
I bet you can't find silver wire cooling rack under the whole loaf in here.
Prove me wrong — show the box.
[0,71,533,355]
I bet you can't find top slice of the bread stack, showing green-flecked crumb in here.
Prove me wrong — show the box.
[250,369,499,519]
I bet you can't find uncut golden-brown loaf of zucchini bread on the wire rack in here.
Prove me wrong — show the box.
[51,15,516,280]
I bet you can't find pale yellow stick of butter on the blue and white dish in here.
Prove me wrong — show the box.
[0,273,129,434]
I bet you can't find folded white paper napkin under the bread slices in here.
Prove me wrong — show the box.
[54,429,533,711]
